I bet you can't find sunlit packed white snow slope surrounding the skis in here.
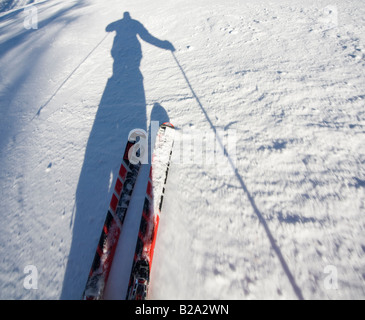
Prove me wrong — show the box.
[0,0,365,299]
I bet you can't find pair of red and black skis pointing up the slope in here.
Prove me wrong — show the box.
[83,123,174,300]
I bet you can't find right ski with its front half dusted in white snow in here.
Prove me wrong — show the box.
[126,123,175,300]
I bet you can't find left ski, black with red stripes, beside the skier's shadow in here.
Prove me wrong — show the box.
[82,134,141,300]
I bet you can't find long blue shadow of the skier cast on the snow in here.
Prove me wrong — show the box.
[61,12,174,299]
